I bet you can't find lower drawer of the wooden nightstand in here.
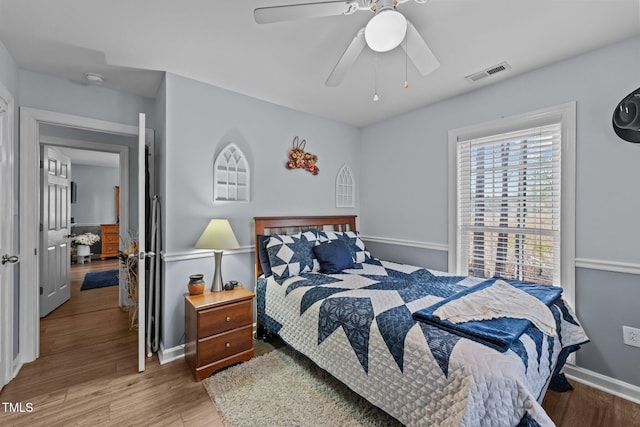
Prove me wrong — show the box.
[197,324,253,366]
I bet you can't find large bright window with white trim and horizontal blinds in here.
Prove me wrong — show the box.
[449,104,575,304]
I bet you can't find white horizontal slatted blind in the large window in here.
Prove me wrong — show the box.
[456,123,562,285]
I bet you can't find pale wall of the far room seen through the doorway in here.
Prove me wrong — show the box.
[71,165,120,225]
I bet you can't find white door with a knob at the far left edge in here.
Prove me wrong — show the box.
[0,85,18,389]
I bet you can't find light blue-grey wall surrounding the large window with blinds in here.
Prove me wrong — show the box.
[360,38,640,386]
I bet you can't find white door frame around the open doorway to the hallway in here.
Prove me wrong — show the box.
[19,107,153,364]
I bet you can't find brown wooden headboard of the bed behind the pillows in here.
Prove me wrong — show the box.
[253,215,357,278]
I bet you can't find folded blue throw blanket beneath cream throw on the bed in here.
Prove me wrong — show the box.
[413,278,562,353]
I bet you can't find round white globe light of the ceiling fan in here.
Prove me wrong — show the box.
[364,8,407,52]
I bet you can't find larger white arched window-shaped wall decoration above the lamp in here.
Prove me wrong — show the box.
[213,143,250,202]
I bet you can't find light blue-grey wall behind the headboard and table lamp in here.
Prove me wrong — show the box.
[161,73,360,348]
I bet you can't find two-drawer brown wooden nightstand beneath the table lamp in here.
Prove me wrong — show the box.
[184,286,255,381]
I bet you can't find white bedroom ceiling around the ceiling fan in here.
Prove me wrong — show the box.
[0,0,640,127]
